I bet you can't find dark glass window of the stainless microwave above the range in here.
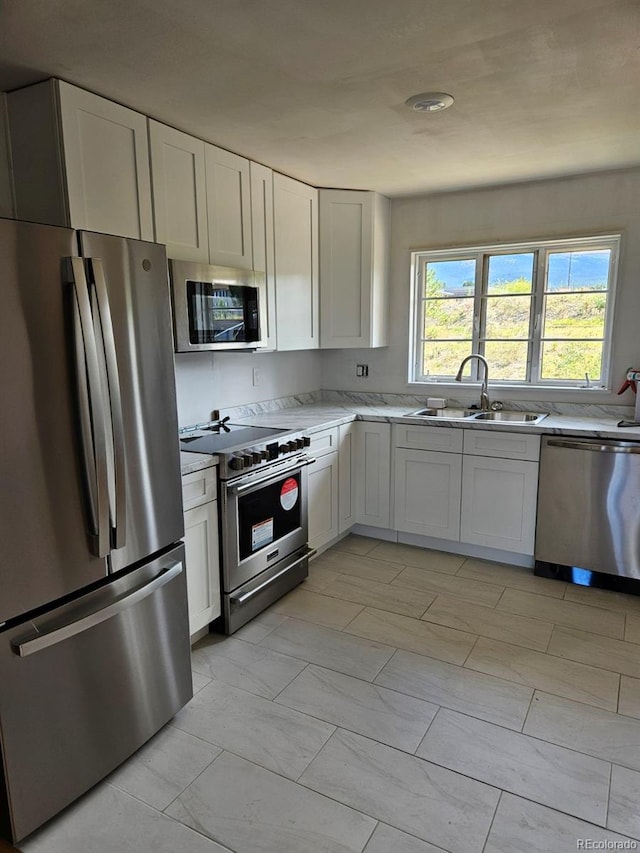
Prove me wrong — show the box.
[187,281,259,344]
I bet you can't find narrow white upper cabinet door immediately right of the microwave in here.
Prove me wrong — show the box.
[249,163,276,352]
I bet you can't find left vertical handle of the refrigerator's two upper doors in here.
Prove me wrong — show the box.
[67,257,110,557]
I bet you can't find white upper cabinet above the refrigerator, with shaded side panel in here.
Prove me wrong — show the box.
[7,80,154,240]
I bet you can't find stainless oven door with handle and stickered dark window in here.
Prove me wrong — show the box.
[221,456,314,593]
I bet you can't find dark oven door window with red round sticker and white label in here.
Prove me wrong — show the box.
[238,472,302,561]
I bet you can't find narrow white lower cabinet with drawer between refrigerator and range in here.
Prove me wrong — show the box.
[182,468,222,636]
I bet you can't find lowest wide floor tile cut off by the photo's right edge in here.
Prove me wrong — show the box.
[523,693,640,770]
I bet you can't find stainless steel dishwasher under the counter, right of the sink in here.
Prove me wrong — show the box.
[535,436,640,588]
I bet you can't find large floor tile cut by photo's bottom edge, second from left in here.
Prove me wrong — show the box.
[167,752,375,853]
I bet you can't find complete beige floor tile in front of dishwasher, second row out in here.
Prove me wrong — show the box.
[497,589,624,639]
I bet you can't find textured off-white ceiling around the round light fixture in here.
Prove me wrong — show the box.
[0,0,640,195]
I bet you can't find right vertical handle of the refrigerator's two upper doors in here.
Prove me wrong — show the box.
[88,258,127,548]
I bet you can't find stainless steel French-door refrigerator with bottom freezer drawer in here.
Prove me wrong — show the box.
[0,220,192,842]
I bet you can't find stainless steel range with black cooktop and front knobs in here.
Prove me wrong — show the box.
[180,419,315,634]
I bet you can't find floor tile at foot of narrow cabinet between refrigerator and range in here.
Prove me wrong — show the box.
[191,637,306,699]
